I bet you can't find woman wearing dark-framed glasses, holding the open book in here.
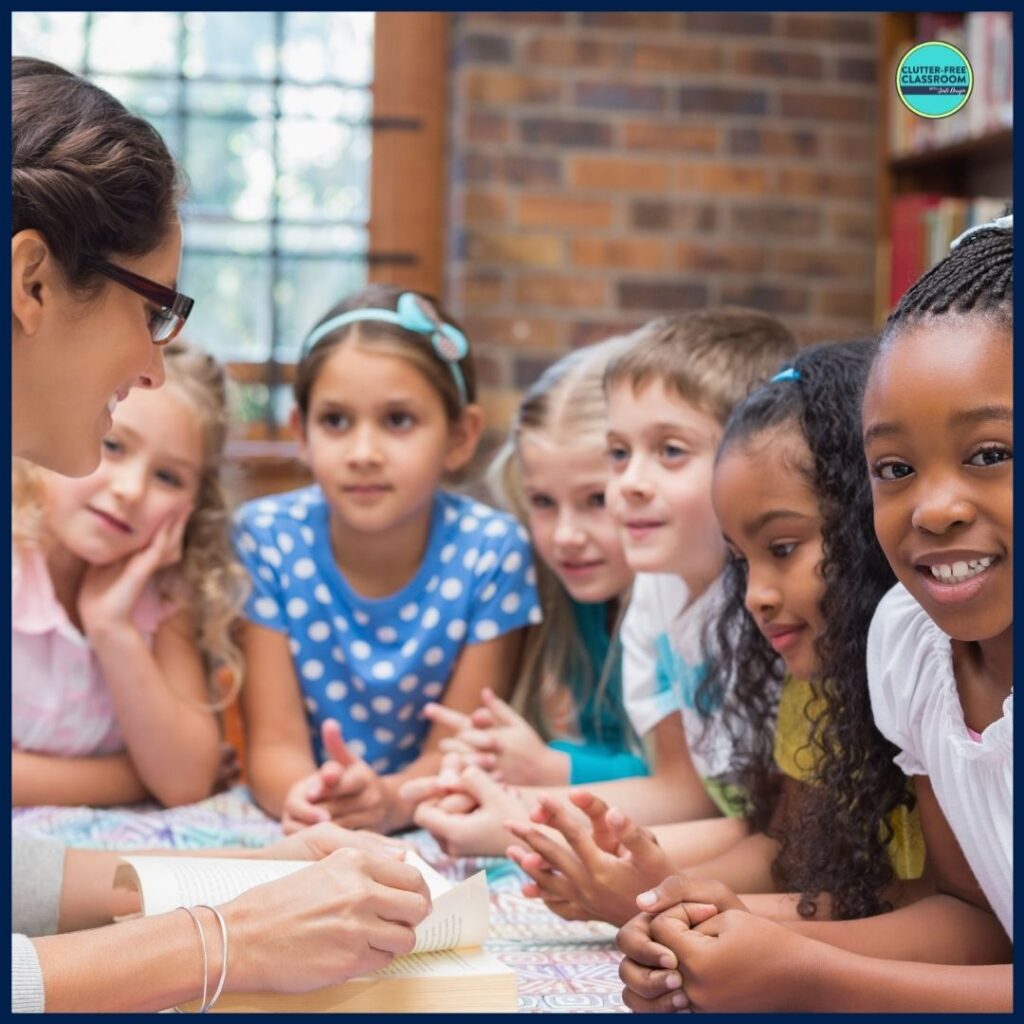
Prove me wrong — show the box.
[11,57,429,1012]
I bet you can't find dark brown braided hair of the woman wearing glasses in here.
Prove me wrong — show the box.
[10,56,184,292]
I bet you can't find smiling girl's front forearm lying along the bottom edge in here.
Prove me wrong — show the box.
[794,944,1013,1013]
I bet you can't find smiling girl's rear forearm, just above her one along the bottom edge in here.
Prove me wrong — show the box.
[786,895,1013,965]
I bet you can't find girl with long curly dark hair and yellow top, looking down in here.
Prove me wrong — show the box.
[515,341,924,924]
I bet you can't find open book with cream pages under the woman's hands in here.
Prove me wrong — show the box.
[114,853,516,1013]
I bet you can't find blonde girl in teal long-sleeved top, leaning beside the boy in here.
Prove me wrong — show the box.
[427,339,647,785]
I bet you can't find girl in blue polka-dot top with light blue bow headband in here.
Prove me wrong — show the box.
[237,286,540,831]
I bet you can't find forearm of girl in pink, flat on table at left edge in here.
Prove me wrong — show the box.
[11,751,150,807]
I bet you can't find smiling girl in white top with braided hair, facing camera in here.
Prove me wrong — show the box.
[620,221,1013,1012]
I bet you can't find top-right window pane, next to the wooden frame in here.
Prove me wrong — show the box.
[282,10,374,85]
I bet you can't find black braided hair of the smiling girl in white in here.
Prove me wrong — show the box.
[880,211,1014,339]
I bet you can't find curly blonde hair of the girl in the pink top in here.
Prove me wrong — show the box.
[11,340,250,711]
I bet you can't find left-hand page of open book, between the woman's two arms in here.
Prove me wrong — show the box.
[114,857,312,916]
